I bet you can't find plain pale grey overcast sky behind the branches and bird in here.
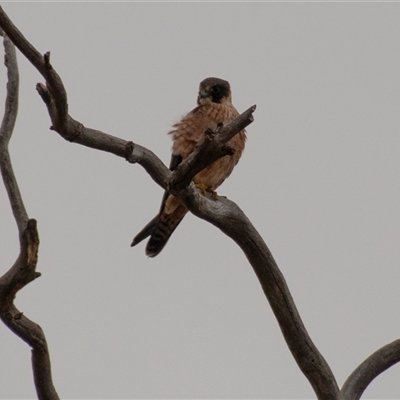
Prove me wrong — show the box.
[0,3,400,399]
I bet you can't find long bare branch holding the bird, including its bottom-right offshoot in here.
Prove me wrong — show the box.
[0,3,399,400]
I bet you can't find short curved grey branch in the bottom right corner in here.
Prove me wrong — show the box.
[342,339,400,400]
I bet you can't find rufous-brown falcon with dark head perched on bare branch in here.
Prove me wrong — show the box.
[131,77,246,257]
